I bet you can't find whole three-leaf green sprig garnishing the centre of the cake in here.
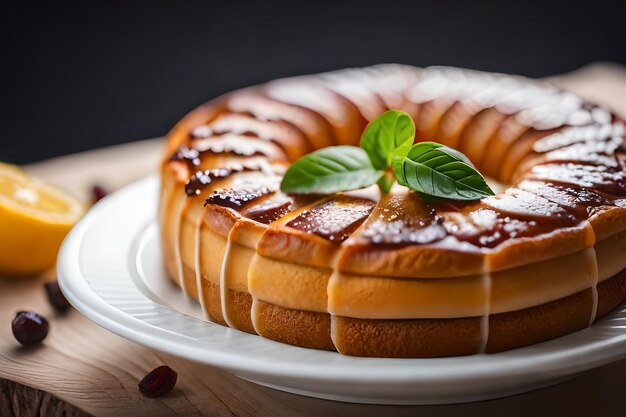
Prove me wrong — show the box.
[280,110,494,200]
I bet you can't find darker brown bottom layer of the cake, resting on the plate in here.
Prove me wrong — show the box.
[172,264,626,358]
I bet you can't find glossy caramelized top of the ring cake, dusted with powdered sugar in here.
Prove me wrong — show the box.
[164,65,626,274]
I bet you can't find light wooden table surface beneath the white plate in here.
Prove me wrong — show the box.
[0,64,626,417]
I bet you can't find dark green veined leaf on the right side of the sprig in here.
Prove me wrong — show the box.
[392,142,494,200]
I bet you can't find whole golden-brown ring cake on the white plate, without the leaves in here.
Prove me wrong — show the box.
[159,65,626,358]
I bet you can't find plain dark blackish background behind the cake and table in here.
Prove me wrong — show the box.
[0,0,626,163]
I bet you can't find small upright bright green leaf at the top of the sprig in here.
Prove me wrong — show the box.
[361,110,415,169]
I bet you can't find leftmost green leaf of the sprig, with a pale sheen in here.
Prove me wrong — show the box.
[280,146,384,194]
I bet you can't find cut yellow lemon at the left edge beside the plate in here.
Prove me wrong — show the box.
[0,163,85,277]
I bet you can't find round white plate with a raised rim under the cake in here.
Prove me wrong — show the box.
[58,177,626,404]
